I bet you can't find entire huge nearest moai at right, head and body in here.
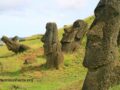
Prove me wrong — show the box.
[82,0,120,90]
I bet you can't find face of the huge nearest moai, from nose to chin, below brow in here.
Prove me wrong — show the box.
[84,23,104,68]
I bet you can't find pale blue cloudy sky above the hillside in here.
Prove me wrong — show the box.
[0,0,99,37]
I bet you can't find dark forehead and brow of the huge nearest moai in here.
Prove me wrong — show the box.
[95,0,120,19]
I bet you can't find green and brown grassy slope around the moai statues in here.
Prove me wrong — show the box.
[0,17,120,90]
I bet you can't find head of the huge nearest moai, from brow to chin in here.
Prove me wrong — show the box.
[84,0,120,68]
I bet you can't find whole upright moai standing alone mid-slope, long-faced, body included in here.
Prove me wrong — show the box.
[41,23,64,69]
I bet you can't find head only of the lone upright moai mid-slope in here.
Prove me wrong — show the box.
[41,22,59,55]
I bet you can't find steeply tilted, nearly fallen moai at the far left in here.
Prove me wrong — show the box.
[1,36,30,53]
